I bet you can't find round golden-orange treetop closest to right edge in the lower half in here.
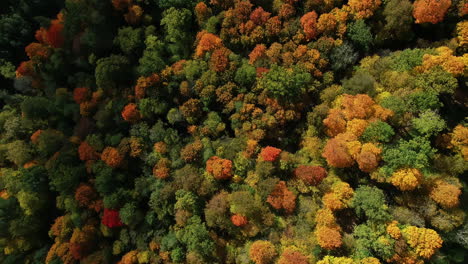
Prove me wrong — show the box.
[429,180,461,208]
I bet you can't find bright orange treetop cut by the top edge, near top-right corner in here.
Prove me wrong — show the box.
[413,0,452,24]
